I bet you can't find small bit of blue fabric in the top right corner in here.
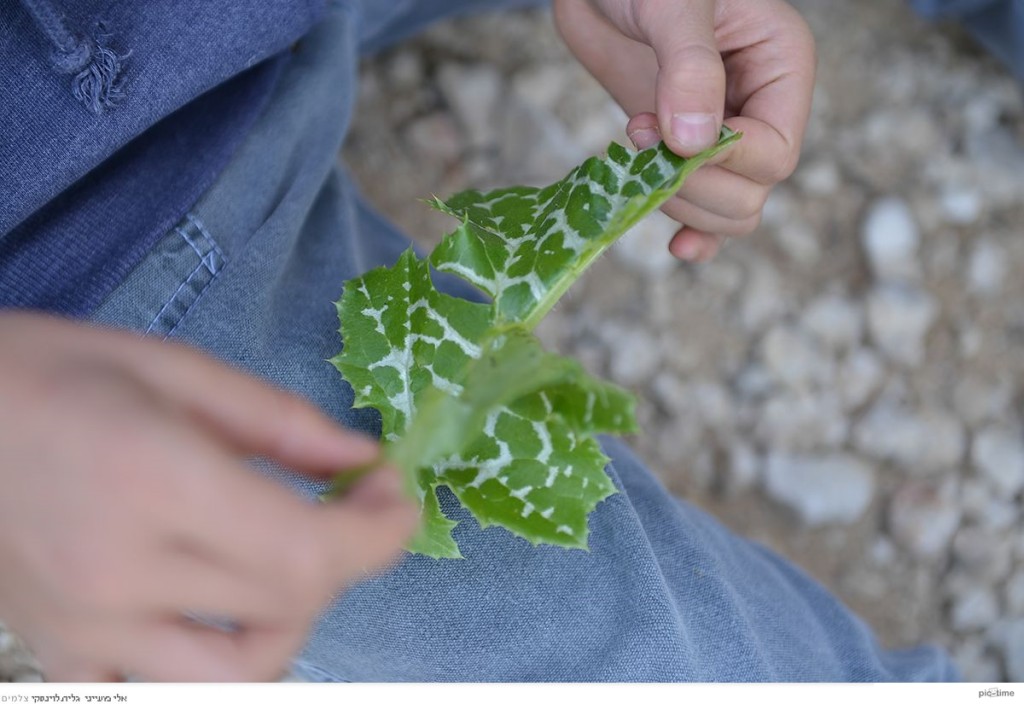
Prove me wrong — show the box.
[911,0,1024,81]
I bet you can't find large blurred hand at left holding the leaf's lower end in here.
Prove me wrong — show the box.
[0,313,417,680]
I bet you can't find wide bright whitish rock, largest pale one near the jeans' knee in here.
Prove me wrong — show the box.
[764,452,874,526]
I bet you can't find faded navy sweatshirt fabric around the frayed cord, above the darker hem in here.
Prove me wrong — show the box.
[0,0,324,233]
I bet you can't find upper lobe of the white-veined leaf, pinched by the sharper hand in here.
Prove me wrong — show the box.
[430,128,740,328]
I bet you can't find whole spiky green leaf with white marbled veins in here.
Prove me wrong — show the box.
[329,131,739,558]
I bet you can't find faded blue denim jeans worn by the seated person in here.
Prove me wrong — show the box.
[94,3,955,681]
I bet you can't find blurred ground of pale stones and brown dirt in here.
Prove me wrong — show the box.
[0,0,1024,680]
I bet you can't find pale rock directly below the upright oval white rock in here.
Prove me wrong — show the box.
[867,284,939,366]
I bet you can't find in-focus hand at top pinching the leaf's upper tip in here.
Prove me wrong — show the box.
[555,0,815,261]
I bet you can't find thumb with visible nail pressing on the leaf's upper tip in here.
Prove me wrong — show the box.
[638,0,725,157]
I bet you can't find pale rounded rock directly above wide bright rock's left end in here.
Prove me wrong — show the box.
[755,392,850,452]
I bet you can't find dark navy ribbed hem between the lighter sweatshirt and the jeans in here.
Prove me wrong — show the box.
[0,54,288,316]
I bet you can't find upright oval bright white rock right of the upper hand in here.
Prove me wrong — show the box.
[861,197,921,280]
